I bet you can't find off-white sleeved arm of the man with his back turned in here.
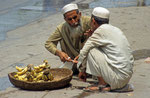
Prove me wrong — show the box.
[77,30,106,70]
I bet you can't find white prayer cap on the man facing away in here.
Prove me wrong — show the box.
[92,7,110,19]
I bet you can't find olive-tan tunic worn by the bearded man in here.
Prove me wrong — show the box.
[45,16,90,59]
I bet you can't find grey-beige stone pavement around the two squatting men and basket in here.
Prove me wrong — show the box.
[0,6,150,98]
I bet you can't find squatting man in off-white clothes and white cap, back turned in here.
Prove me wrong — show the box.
[77,7,134,91]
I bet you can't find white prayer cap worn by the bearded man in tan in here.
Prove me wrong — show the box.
[62,4,78,14]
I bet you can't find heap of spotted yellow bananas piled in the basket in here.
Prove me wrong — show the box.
[14,60,54,82]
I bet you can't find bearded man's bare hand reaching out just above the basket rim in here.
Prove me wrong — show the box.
[56,50,72,62]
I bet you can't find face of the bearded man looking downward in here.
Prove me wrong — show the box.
[65,10,81,27]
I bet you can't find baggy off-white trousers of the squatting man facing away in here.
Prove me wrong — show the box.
[86,48,131,89]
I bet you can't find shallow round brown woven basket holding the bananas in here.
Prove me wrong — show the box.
[8,68,73,90]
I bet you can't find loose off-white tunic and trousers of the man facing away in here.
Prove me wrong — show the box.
[77,24,134,89]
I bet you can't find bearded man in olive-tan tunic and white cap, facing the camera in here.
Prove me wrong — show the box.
[45,4,90,73]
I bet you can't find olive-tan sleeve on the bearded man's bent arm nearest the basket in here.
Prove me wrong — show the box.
[45,27,62,55]
